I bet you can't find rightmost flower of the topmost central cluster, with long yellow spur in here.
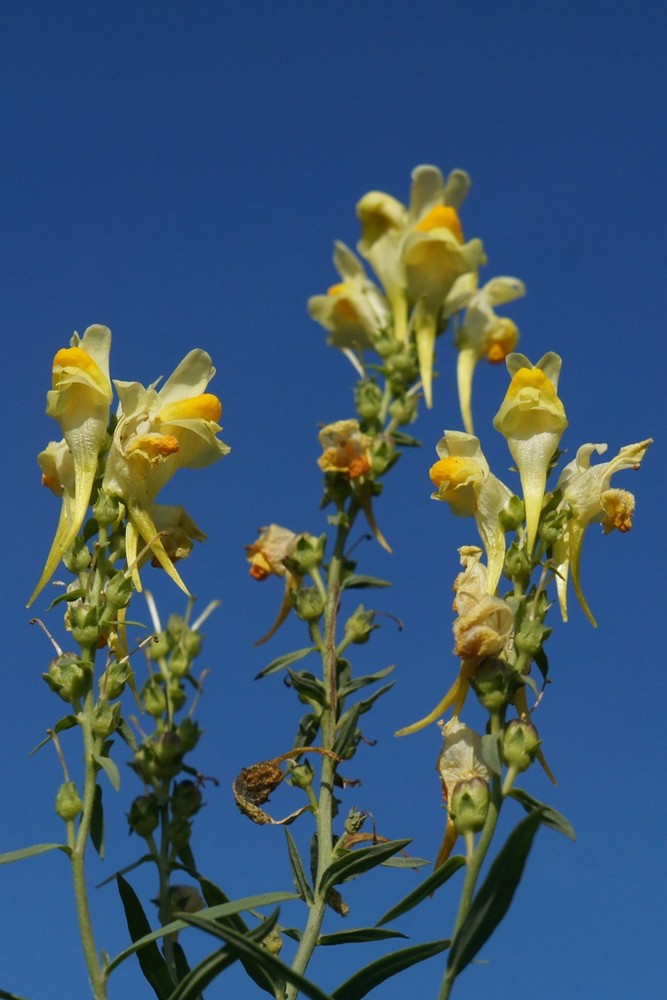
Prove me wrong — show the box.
[456,277,526,434]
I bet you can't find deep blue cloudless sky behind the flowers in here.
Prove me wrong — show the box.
[0,0,667,1000]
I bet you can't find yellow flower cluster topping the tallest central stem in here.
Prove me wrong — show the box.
[308,165,525,416]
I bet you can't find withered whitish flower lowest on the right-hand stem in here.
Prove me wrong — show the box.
[435,716,491,868]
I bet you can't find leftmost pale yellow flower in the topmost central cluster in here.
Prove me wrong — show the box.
[308,242,389,351]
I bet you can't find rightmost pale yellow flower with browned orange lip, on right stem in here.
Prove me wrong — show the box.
[553,438,652,625]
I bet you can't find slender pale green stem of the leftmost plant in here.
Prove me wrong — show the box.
[68,676,107,1000]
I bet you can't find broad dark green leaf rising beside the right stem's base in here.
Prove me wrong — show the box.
[447,811,542,976]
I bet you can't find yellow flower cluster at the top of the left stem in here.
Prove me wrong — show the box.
[29,325,229,604]
